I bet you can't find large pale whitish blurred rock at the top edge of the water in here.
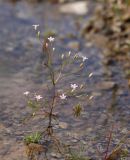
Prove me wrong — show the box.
[60,1,88,15]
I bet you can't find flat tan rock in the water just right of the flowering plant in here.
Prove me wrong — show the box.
[97,81,117,90]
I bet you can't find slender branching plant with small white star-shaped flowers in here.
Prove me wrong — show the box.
[24,24,93,160]
